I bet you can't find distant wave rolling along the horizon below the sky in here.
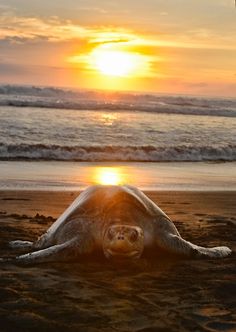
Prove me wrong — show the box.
[0,85,236,117]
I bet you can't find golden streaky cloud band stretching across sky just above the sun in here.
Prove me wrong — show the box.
[0,12,236,49]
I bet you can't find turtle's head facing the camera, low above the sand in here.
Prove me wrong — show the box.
[103,224,144,259]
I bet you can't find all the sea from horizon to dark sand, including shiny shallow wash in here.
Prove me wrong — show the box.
[0,85,236,190]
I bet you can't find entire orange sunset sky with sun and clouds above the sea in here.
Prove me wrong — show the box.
[0,0,236,96]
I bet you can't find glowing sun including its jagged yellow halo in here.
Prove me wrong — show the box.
[67,43,153,81]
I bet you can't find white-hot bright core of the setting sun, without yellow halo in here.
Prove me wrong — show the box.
[89,47,147,77]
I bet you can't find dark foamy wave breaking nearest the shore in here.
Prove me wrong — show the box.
[0,144,236,162]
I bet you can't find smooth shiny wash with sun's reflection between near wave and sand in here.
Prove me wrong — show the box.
[0,161,236,191]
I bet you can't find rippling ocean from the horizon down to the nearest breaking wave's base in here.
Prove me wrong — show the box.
[0,86,236,162]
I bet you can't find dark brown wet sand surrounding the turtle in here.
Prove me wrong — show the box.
[0,191,236,332]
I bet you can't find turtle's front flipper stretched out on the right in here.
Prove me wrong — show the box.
[157,234,232,258]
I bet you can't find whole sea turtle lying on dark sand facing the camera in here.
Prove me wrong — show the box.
[1,185,231,264]
